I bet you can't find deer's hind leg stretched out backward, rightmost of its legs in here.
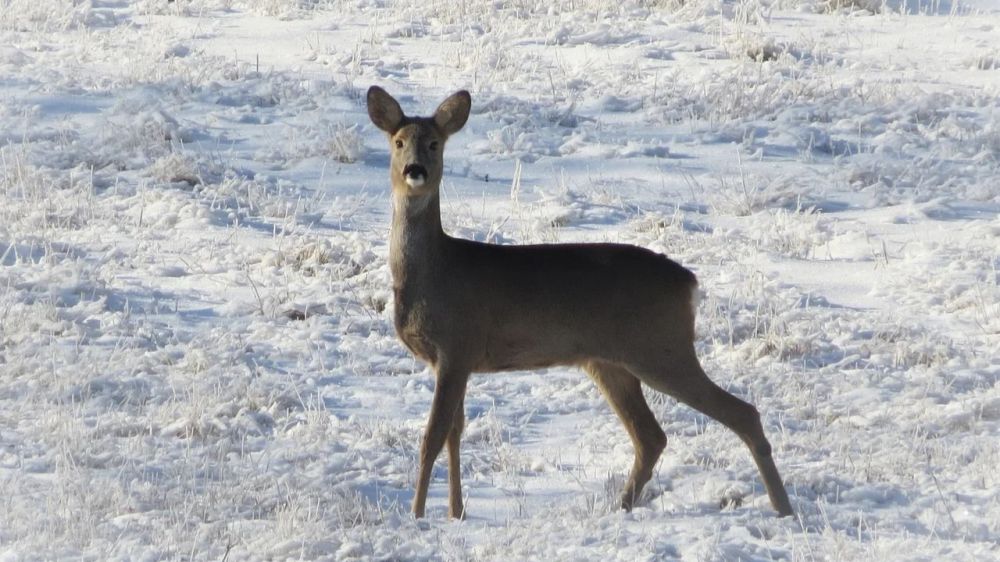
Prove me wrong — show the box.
[633,347,792,517]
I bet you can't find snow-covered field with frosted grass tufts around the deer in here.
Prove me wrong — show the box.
[0,0,1000,561]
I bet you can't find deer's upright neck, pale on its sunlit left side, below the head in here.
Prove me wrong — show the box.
[389,190,448,289]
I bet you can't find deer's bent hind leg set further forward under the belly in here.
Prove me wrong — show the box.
[586,362,667,511]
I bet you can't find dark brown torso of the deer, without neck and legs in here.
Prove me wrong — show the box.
[395,230,696,372]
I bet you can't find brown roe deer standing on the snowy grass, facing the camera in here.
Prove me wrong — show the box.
[366,86,792,519]
